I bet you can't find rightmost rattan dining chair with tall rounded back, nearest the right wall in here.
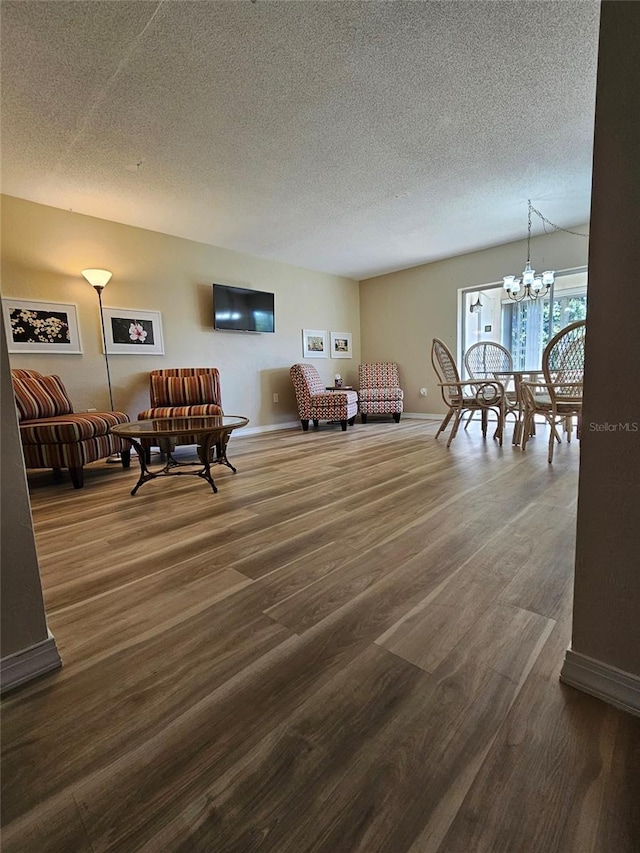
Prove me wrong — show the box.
[521,320,586,463]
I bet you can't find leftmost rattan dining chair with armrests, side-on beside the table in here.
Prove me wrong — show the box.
[431,338,505,447]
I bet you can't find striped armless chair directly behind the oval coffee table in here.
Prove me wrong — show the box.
[138,367,222,455]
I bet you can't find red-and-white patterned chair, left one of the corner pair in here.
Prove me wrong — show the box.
[289,364,358,432]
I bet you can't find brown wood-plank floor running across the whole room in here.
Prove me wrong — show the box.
[2,420,640,853]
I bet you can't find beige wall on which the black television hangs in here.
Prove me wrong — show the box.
[2,196,360,428]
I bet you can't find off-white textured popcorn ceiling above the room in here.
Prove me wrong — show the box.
[0,0,599,279]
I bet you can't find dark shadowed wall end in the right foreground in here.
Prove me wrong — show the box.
[572,3,640,677]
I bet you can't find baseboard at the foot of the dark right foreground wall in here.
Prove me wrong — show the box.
[560,649,640,717]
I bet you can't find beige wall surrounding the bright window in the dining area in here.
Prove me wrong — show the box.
[360,226,588,413]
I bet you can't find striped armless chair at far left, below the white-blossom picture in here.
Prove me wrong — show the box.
[11,370,131,489]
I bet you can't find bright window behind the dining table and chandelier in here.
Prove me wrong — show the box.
[459,267,587,370]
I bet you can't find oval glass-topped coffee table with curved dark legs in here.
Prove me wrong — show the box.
[111,415,249,495]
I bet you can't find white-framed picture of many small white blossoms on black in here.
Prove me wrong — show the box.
[2,299,82,354]
